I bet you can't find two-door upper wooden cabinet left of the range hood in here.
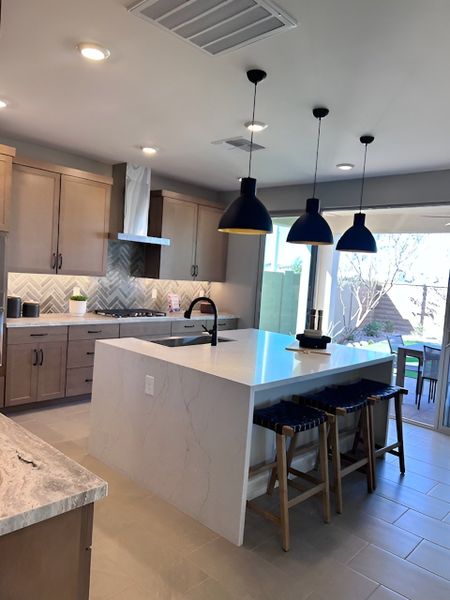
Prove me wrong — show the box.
[7,159,112,275]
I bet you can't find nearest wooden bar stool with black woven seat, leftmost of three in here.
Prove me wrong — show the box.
[247,401,330,552]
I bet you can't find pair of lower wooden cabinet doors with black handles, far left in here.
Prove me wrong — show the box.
[5,341,67,406]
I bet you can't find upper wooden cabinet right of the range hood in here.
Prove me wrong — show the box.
[145,190,227,281]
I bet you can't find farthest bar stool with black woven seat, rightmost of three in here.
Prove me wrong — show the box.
[355,379,408,489]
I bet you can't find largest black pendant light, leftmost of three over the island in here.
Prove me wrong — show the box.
[218,69,272,235]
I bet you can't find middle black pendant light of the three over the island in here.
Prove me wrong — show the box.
[287,108,333,246]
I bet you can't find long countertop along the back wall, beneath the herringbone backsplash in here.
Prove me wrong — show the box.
[6,310,239,329]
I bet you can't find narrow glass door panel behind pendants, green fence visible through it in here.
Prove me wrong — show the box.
[259,217,311,335]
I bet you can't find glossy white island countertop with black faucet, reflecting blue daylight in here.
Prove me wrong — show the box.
[99,329,392,389]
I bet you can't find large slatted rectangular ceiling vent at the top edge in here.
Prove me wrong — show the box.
[128,0,297,56]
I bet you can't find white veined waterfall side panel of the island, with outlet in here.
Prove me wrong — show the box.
[89,344,253,544]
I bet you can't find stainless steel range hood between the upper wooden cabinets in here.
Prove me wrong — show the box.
[109,163,170,246]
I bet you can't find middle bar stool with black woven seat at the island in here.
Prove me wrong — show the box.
[293,385,374,513]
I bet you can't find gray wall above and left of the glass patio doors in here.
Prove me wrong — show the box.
[212,170,450,327]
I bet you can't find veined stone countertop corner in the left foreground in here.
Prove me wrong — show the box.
[0,415,108,535]
